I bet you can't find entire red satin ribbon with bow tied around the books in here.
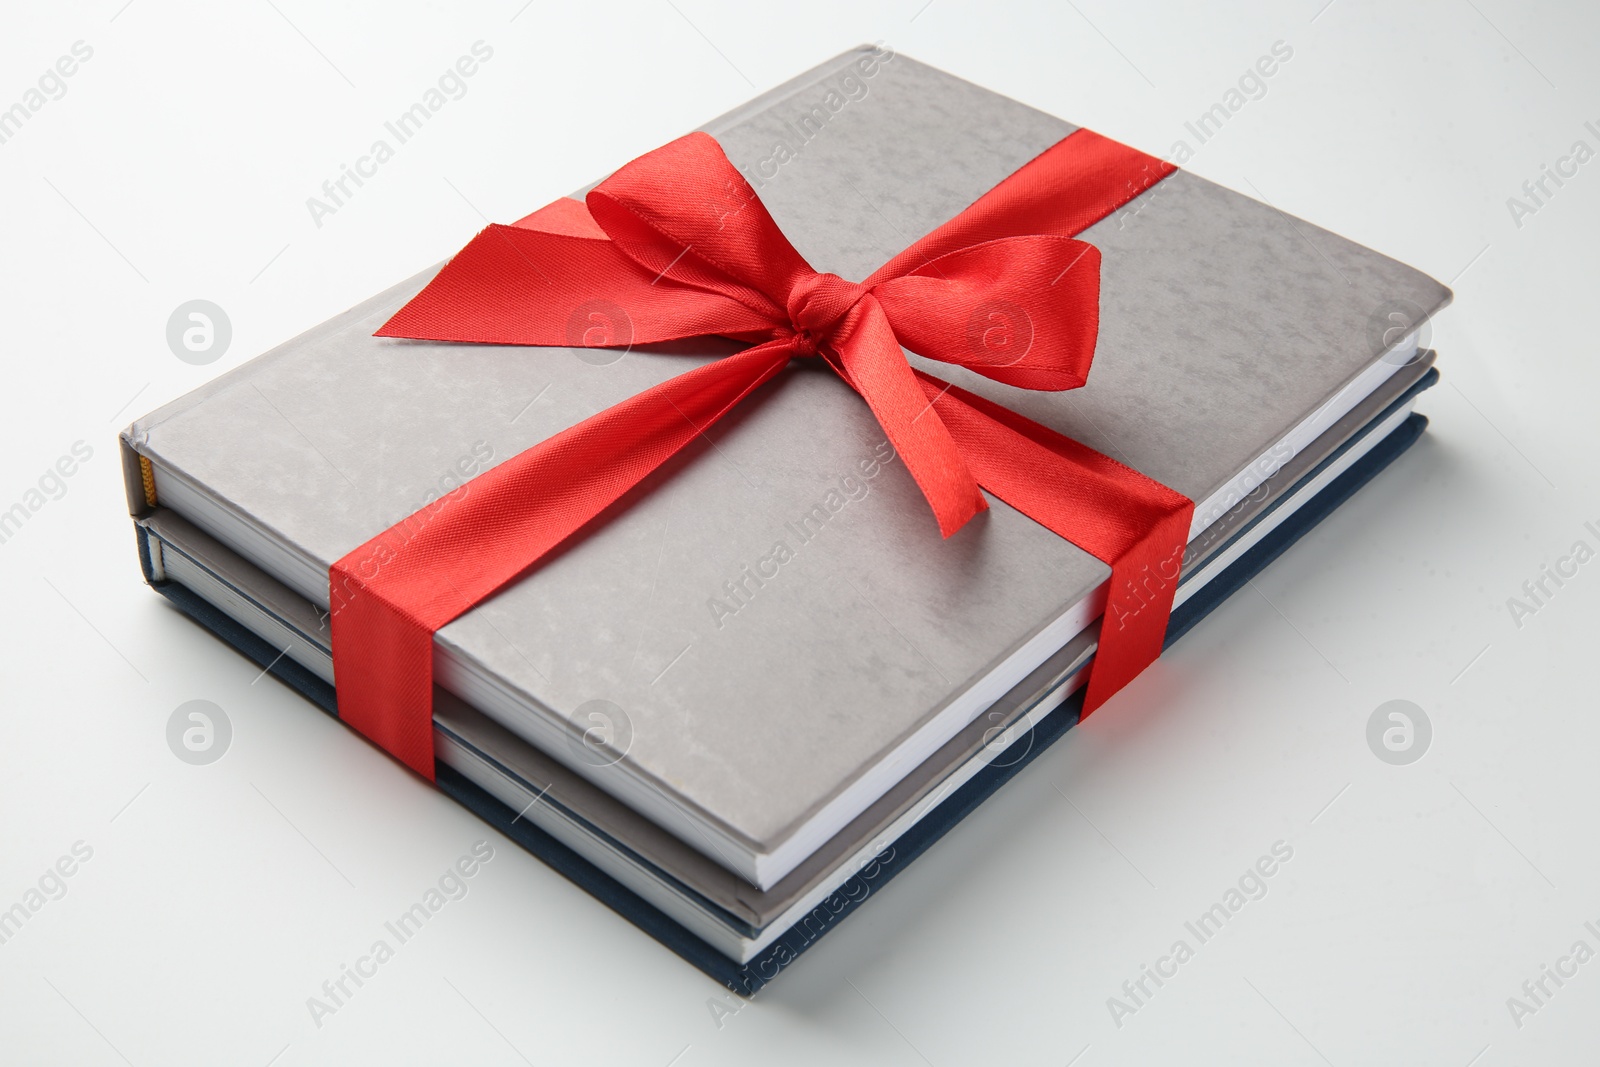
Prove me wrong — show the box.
[330,130,1194,779]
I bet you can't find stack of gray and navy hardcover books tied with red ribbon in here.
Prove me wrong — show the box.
[123,48,1450,993]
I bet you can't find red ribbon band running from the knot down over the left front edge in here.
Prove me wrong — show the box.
[328,342,792,781]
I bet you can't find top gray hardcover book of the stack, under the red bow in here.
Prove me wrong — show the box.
[125,50,1448,888]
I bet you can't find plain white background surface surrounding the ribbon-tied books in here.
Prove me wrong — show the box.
[0,0,1600,1067]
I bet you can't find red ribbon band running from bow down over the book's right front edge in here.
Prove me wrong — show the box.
[917,371,1194,717]
